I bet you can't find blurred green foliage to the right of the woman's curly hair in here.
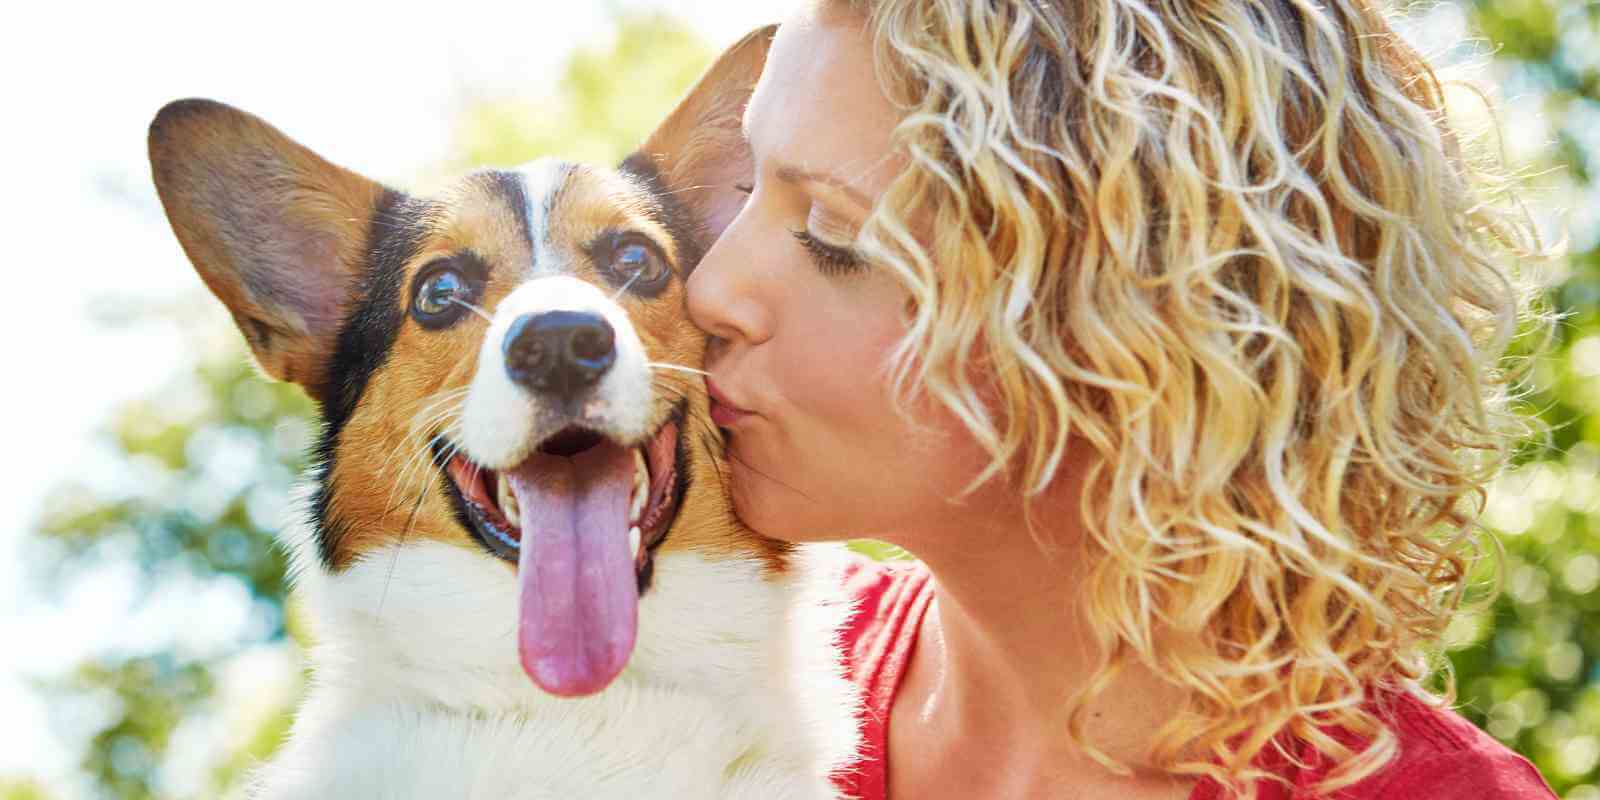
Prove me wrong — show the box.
[1450,0,1600,800]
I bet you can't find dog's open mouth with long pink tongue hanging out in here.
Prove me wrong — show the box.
[443,421,682,696]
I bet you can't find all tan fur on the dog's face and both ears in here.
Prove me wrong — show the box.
[150,27,786,588]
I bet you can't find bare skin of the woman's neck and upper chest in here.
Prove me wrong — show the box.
[893,457,1203,789]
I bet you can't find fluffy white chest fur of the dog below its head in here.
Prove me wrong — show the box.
[251,531,856,800]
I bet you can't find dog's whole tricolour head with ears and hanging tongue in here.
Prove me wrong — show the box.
[150,29,784,694]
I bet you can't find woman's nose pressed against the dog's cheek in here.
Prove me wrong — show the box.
[688,213,771,344]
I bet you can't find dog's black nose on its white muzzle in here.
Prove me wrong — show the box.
[501,310,616,400]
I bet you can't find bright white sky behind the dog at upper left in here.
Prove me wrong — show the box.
[0,0,790,797]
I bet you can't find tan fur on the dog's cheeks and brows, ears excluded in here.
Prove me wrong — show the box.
[307,170,787,571]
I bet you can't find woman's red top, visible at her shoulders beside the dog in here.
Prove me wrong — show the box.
[837,558,1555,800]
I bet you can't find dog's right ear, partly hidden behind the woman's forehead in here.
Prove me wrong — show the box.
[622,26,778,253]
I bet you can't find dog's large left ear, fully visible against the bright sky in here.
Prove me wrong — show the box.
[149,99,384,400]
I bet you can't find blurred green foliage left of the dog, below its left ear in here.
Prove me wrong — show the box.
[18,315,314,798]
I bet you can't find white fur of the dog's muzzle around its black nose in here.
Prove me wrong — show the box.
[461,275,653,469]
